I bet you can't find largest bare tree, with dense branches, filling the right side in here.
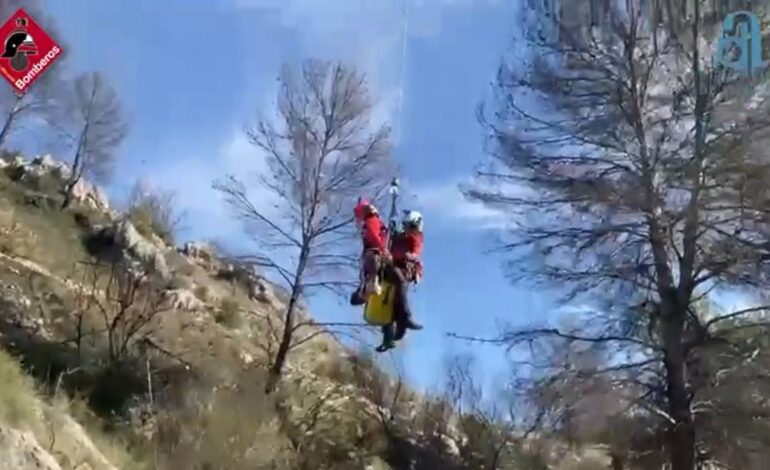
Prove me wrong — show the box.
[466,1,770,470]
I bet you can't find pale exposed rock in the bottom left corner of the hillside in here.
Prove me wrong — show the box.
[0,426,61,470]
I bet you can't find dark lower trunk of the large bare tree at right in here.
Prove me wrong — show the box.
[662,302,695,470]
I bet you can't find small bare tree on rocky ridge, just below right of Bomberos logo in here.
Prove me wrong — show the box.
[55,72,128,208]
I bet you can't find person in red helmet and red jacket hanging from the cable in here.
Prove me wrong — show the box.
[350,200,387,305]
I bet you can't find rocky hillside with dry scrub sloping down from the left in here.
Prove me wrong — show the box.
[0,155,607,470]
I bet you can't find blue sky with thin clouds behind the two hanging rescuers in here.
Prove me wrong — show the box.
[36,0,552,392]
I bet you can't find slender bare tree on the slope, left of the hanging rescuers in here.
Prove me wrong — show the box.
[214,60,392,393]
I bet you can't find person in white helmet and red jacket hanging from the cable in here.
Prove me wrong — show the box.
[377,211,424,352]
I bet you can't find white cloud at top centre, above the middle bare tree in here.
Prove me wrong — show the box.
[231,0,501,140]
